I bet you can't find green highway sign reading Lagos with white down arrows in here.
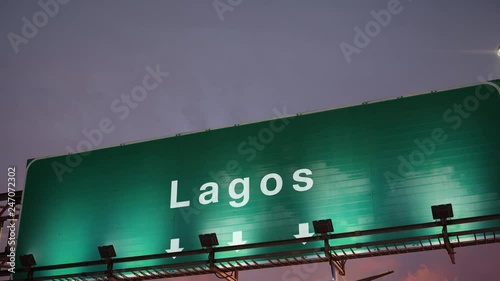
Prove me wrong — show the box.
[16,80,500,276]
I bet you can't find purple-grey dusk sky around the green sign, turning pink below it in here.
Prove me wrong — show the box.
[0,0,500,281]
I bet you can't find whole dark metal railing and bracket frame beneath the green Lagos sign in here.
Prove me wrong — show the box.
[0,191,500,281]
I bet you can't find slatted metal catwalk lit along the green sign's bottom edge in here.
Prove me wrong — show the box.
[5,223,500,281]
